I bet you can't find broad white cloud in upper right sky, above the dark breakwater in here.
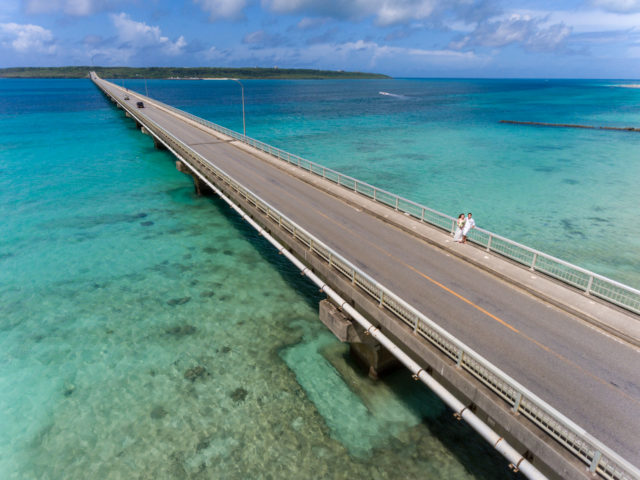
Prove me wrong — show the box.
[450,14,571,51]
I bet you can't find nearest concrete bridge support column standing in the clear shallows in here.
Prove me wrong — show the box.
[320,300,399,380]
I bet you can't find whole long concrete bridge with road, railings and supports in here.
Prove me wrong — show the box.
[91,73,640,479]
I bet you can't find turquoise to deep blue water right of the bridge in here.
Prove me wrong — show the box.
[141,79,640,288]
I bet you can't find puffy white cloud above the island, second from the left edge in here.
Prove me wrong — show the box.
[111,13,187,56]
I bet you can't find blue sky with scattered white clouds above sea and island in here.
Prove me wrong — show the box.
[0,0,640,79]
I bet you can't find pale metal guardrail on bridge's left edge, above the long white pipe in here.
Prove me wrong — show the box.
[94,78,640,480]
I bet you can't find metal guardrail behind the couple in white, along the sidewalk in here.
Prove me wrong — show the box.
[145,100,640,313]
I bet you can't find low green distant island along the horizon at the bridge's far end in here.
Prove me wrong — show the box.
[0,67,391,80]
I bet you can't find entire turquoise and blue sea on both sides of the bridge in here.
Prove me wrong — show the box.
[0,79,640,479]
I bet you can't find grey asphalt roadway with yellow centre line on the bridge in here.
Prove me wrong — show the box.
[95,77,640,465]
